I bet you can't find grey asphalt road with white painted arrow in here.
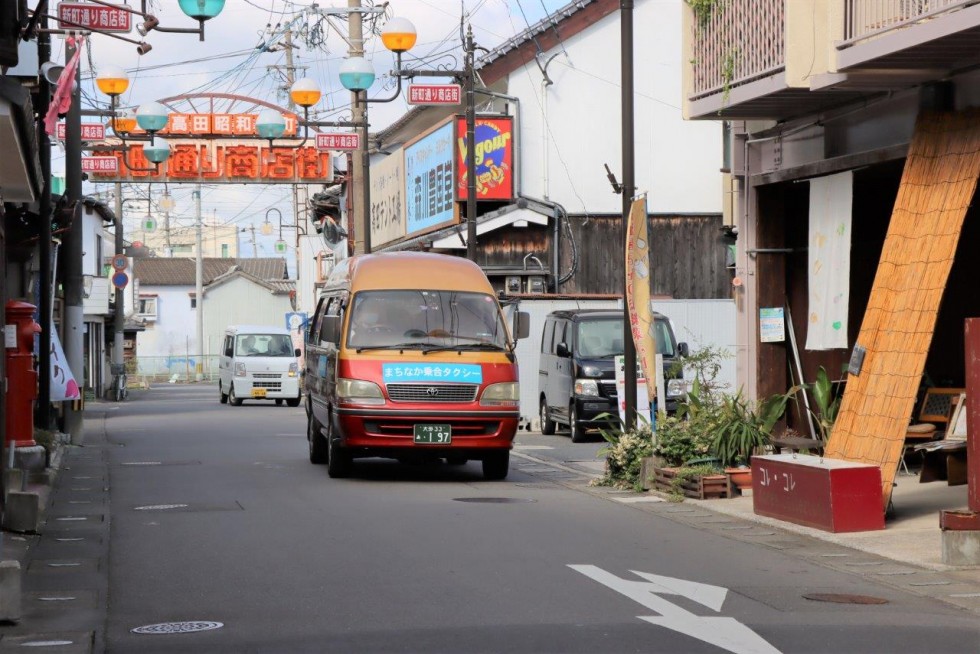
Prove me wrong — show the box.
[90,385,980,654]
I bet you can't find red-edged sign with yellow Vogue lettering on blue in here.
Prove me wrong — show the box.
[456,116,514,201]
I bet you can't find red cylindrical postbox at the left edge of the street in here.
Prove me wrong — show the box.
[4,300,41,447]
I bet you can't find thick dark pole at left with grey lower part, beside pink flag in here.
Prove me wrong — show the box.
[63,38,85,445]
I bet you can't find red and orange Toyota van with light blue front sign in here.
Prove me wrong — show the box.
[304,252,529,479]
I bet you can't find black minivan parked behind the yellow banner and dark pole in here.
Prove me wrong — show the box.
[538,309,688,443]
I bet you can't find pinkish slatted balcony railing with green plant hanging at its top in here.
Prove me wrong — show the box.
[691,0,786,100]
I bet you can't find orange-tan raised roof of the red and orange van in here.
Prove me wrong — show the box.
[327,252,494,295]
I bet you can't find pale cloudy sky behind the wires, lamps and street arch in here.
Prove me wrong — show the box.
[52,0,569,276]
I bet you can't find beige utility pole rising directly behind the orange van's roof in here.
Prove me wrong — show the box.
[347,0,371,254]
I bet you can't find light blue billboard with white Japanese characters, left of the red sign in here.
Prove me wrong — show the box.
[405,121,455,235]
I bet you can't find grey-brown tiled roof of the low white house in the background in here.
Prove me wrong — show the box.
[133,257,288,287]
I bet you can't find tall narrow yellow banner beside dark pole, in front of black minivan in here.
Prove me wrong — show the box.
[626,196,657,406]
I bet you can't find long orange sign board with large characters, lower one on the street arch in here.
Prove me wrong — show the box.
[92,140,333,184]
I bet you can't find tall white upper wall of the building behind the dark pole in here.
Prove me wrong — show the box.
[506,0,722,213]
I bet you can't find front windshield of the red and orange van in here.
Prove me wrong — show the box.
[347,290,507,349]
